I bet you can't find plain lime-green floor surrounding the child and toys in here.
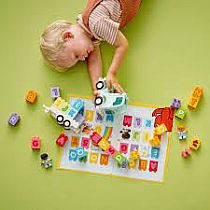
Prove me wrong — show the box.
[0,0,210,210]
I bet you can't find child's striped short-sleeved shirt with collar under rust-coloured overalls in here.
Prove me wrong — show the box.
[77,0,122,45]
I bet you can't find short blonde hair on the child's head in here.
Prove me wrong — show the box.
[40,20,72,71]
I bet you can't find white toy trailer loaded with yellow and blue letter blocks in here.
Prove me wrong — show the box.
[43,97,85,133]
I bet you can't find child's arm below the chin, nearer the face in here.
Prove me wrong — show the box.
[87,45,102,95]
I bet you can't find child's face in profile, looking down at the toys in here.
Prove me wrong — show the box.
[58,29,94,68]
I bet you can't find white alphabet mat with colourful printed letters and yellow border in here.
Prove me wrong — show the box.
[59,97,173,182]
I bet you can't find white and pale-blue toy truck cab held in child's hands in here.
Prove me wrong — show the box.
[95,78,128,113]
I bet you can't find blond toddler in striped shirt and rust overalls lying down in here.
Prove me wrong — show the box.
[40,0,141,95]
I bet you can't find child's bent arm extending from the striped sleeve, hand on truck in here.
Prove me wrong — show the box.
[106,31,128,93]
